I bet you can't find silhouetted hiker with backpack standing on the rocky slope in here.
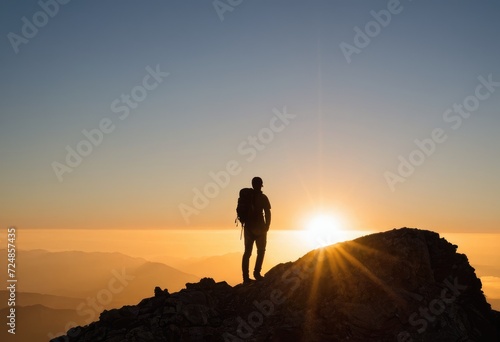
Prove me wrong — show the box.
[236,177,271,283]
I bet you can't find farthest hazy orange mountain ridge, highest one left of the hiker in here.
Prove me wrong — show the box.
[0,249,200,308]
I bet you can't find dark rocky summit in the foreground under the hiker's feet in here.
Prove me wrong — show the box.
[52,228,500,342]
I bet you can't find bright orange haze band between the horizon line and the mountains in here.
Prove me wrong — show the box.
[0,227,500,299]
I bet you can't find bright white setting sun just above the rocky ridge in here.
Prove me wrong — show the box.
[305,213,346,248]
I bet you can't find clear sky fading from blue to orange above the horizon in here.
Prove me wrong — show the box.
[0,0,500,232]
